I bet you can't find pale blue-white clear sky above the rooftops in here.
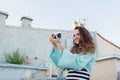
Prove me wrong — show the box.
[0,0,120,46]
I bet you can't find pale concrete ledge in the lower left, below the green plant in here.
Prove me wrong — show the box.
[0,63,47,80]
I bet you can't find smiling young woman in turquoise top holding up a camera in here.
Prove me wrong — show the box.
[50,26,96,80]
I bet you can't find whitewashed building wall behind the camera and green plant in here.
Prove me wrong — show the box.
[0,26,73,64]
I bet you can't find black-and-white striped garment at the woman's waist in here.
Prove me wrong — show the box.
[66,69,90,80]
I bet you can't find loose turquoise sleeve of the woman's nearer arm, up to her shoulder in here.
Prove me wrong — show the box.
[58,50,95,70]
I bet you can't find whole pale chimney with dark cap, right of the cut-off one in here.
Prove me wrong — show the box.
[20,16,33,28]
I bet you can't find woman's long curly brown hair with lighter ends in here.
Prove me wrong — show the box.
[70,26,95,54]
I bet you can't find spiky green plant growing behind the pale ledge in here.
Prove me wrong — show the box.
[5,49,25,64]
